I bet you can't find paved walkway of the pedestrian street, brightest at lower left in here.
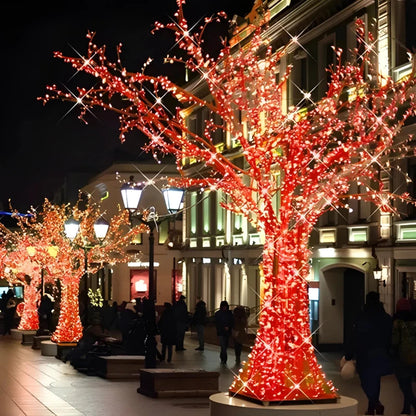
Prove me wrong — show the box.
[0,333,402,416]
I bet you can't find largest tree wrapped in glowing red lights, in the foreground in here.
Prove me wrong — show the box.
[43,0,415,403]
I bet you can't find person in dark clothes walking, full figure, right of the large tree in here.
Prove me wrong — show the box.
[345,292,393,415]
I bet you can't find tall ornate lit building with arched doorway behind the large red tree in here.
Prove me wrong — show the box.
[182,0,416,346]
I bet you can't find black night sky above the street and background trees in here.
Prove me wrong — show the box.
[0,0,253,212]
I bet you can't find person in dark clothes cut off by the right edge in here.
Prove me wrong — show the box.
[392,298,416,416]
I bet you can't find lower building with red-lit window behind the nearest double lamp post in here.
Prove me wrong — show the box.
[82,162,184,305]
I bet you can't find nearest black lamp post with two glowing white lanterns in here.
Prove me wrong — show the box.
[121,176,184,368]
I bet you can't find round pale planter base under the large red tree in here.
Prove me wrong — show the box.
[209,393,358,416]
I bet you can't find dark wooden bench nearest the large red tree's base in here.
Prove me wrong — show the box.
[137,368,220,397]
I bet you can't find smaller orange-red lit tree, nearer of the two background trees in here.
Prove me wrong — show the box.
[37,201,147,343]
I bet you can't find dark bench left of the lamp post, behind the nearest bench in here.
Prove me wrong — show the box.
[92,355,145,379]
